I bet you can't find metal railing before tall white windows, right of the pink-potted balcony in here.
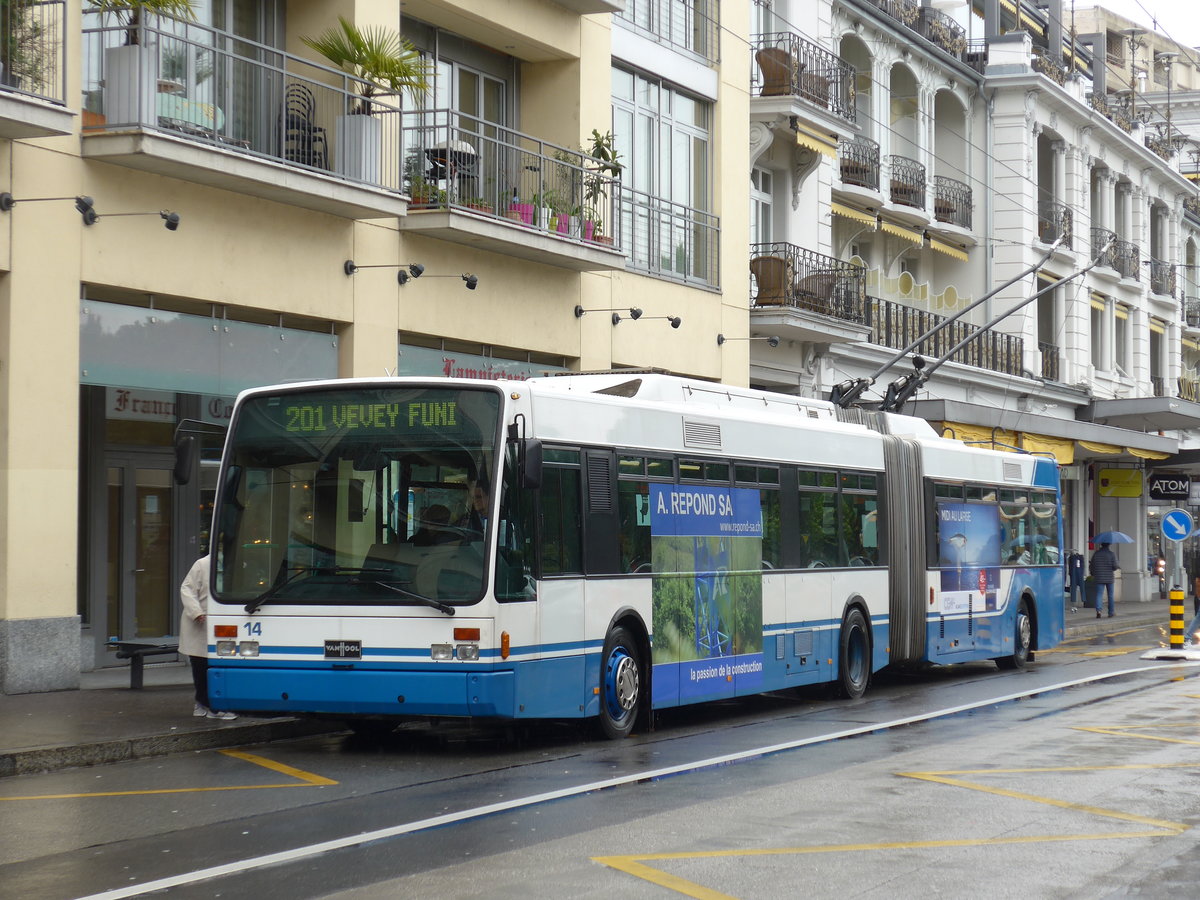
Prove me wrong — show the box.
[618,186,721,288]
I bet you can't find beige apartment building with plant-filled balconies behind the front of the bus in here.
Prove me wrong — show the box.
[0,0,750,694]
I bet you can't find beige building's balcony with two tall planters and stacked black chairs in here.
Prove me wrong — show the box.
[83,16,415,218]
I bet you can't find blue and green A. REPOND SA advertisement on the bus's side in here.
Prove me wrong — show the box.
[649,484,763,706]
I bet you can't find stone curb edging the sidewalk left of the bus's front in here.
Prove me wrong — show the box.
[0,719,344,778]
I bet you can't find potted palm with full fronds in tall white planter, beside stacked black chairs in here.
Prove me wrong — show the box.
[300,16,430,184]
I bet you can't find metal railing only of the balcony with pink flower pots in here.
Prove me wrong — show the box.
[400,109,625,248]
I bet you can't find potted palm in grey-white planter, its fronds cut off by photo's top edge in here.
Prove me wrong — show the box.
[88,0,196,125]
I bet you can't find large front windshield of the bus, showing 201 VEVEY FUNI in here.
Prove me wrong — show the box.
[214,384,500,613]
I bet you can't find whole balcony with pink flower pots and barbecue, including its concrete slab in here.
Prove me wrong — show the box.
[398,109,634,271]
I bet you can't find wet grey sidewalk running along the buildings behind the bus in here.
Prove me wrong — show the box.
[0,607,1171,776]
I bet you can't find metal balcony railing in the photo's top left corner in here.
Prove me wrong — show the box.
[0,0,67,104]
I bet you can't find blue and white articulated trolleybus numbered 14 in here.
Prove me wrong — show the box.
[208,374,1063,738]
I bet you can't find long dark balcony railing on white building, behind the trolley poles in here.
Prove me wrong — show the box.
[866,296,1025,376]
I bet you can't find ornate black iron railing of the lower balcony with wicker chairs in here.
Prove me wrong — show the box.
[750,242,866,323]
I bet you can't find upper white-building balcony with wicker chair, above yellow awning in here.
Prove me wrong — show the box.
[750,31,854,122]
